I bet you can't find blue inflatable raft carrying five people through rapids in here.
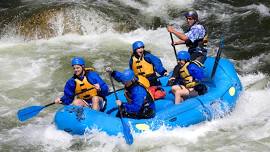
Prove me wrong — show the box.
[54,57,242,135]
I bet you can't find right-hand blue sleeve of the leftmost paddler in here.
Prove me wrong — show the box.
[87,71,109,97]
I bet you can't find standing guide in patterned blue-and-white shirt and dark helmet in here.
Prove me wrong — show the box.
[167,10,208,64]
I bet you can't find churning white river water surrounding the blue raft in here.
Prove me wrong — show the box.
[0,0,270,152]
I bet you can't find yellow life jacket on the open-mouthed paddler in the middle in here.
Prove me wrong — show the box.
[132,56,155,77]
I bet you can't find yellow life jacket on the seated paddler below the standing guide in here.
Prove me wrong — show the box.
[179,60,203,88]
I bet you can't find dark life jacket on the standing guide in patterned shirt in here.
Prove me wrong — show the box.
[185,23,208,53]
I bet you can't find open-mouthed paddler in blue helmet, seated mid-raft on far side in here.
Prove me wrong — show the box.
[129,41,168,86]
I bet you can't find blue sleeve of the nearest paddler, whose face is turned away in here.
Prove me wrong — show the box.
[123,86,147,113]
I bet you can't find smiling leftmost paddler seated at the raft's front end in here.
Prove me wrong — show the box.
[54,57,109,111]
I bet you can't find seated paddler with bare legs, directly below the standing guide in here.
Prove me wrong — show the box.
[168,51,207,104]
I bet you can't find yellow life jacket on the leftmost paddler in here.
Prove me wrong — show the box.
[75,68,98,100]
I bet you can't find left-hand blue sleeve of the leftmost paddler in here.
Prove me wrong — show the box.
[61,78,76,105]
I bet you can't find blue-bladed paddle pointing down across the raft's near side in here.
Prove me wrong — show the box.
[109,73,133,145]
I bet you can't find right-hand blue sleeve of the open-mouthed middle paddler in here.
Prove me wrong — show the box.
[144,53,167,76]
